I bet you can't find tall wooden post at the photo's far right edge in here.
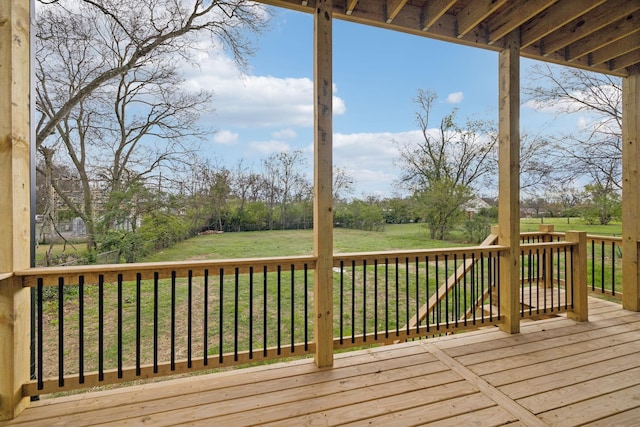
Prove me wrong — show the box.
[622,66,640,311]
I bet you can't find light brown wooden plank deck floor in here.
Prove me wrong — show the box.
[7,298,640,426]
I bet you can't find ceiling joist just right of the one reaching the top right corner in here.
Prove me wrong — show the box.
[565,12,640,61]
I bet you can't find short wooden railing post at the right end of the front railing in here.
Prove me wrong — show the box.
[565,231,589,322]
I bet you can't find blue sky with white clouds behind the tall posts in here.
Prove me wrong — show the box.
[189,9,555,197]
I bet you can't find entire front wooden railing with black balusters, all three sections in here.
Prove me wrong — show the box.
[15,229,586,396]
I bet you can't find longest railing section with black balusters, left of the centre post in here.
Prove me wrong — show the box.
[24,257,315,395]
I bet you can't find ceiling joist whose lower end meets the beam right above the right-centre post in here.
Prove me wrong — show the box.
[487,0,557,44]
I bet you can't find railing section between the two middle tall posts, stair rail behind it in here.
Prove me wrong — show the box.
[334,246,500,348]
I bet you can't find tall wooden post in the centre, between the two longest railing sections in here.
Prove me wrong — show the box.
[313,0,333,367]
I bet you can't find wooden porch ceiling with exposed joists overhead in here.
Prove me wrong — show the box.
[260,0,640,76]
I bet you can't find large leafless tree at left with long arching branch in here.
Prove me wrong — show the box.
[36,0,266,248]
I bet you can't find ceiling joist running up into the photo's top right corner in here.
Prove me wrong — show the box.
[541,0,640,56]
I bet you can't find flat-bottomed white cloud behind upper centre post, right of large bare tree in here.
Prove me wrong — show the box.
[186,53,346,128]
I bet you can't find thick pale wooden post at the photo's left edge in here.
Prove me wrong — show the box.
[0,0,31,420]
